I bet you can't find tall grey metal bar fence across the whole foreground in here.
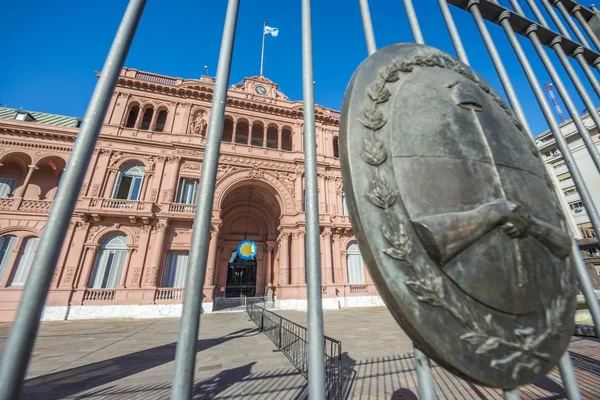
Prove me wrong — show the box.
[0,0,600,400]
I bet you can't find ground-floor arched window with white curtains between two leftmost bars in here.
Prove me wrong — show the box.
[89,233,129,289]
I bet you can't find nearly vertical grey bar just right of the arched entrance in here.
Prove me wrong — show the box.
[302,0,326,399]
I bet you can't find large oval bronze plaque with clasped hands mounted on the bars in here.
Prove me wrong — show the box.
[340,44,576,389]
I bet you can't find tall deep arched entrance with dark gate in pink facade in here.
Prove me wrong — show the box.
[215,180,281,297]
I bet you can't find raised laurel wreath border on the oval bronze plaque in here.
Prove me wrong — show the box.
[359,55,569,379]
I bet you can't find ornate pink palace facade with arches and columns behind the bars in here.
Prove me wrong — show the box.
[0,68,382,320]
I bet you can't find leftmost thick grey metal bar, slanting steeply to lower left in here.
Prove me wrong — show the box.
[0,0,146,400]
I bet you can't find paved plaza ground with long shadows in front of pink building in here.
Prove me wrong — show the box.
[0,308,600,399]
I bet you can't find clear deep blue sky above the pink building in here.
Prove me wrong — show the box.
[0,0,598,133]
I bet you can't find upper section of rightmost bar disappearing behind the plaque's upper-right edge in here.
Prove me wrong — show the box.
[469,2,531,135]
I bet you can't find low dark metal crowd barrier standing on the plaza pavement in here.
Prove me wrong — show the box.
[246,304,343,400]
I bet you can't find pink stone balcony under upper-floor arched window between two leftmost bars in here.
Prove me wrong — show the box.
[75,197,154,219]
